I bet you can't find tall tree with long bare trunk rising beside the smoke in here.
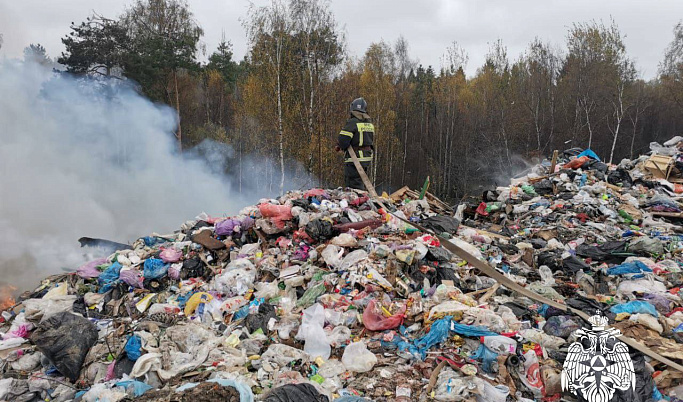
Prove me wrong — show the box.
[121,0,204,152]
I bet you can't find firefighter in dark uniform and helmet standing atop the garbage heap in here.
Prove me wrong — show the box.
[336,98,375,190]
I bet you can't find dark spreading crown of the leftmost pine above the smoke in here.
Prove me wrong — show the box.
[57,14,131,78]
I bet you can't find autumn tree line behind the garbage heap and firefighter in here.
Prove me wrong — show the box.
[10,0,683,200]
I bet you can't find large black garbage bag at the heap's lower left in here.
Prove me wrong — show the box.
[31,312,97,381]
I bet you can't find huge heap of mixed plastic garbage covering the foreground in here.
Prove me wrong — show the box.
[0,141,683,402]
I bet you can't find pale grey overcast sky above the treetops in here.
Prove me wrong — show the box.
[0,0,683,78]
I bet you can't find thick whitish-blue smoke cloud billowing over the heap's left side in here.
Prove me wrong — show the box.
[0,60,262,288]
